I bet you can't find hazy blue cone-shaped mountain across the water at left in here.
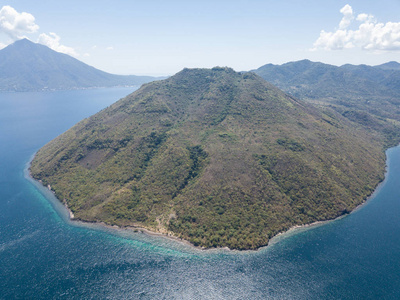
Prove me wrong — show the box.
[0,39,158,91]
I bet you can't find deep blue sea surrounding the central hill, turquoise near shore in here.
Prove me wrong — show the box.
[0,88,400,299]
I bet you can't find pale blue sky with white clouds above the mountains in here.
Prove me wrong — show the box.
[0,0,400,76]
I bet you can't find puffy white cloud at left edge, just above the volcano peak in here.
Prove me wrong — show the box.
[0,5,39,40]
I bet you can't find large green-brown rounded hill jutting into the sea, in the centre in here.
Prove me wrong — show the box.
[31,68,385,249]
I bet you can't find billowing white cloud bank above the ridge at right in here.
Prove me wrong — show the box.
[311,4,400,51]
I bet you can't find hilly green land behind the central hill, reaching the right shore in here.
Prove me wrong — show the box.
[252,60,400,146]
